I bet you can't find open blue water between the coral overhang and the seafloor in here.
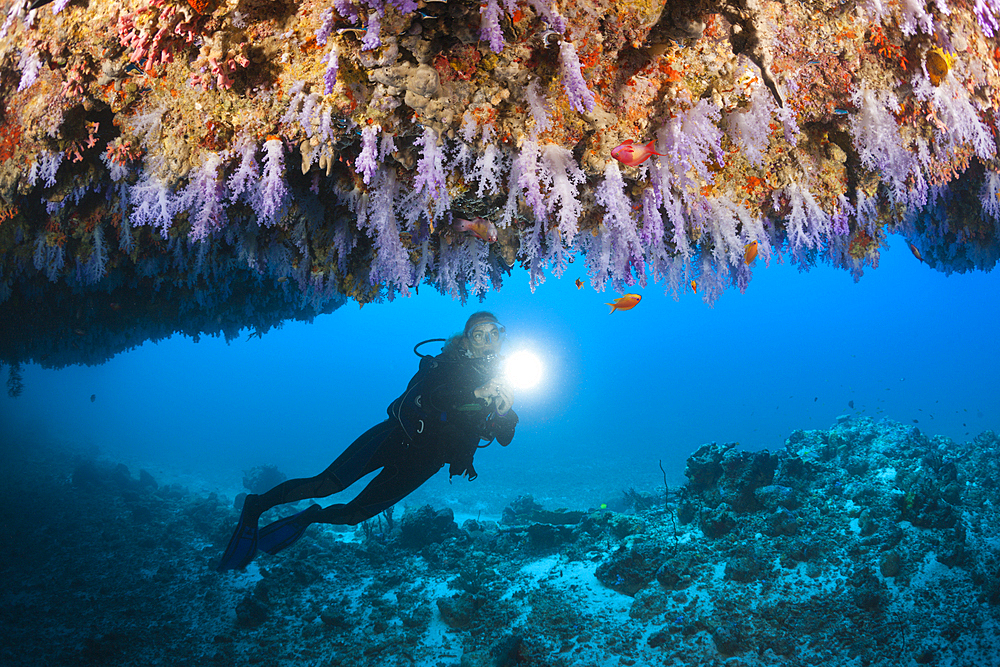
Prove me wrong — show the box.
[0,237,1000,500]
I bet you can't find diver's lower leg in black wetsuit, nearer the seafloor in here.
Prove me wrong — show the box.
[307,443,444,526]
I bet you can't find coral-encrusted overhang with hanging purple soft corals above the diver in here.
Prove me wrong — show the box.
[0,0,1000,365]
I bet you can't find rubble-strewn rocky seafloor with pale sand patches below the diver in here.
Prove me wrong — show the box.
[0,417,1000,667]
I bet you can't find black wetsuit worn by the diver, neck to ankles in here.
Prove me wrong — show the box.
[257,354,517,525]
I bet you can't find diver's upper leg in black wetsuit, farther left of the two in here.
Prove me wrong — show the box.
[254,420,403,516]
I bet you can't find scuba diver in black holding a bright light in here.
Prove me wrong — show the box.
[217,311,518,572]
